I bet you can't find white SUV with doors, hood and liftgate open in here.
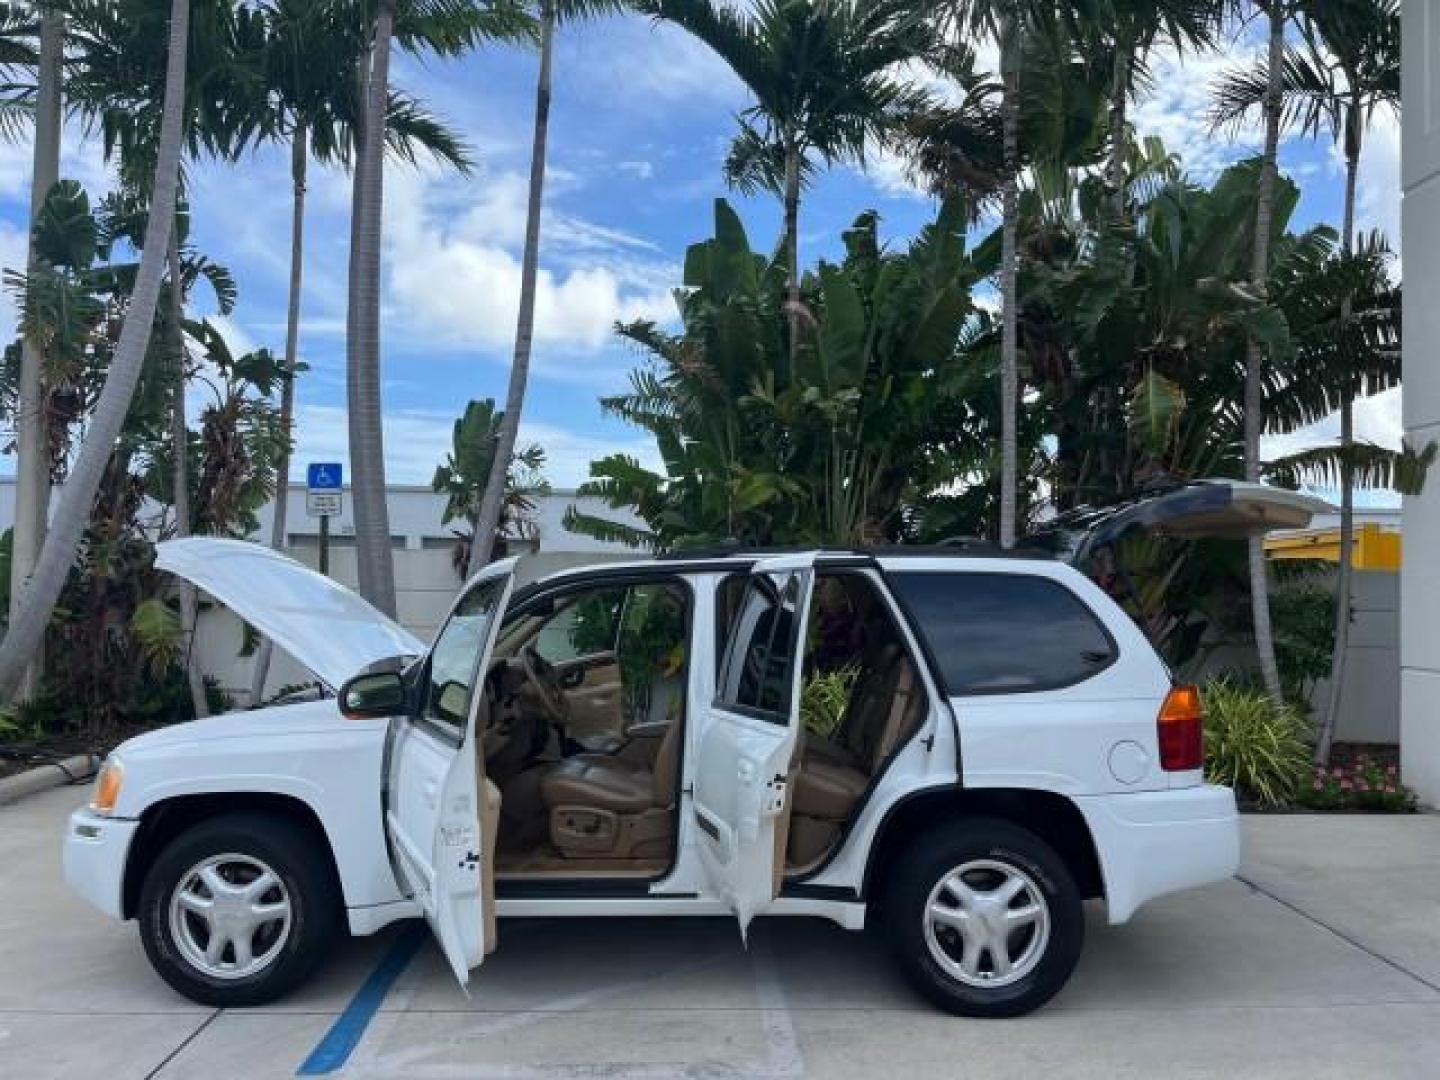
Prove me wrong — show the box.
[65,482,1322,1017]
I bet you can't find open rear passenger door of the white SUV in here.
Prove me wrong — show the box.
[694,554,815,936]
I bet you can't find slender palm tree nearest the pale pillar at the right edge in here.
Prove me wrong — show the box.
[1215,0,1400,765]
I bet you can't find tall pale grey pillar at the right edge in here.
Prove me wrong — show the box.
[1400,0,1440,805]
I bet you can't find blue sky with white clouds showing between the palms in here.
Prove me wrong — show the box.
[0,17,1400,487]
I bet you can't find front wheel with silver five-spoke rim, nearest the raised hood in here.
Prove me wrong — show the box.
[140,814,340,1007]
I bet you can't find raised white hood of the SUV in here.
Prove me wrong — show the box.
[156,537,425,688]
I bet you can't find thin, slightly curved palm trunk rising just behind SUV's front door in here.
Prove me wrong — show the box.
[469,0,556,573]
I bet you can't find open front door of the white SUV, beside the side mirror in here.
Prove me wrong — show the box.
[383,559,516,986]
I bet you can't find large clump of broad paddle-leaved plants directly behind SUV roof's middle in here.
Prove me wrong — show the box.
[566,200,992,550]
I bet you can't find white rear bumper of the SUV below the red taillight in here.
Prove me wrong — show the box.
[1076,783,1240,923]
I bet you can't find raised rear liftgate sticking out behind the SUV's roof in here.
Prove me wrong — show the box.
[1024,480,1332,566]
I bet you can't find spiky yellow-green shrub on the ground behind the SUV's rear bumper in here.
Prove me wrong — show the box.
[1201,677,1310,806]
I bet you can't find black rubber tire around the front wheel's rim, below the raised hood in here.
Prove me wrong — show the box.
[140,814,341,1008]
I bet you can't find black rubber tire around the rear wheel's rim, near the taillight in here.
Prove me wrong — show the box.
[884,818,1084,1017]
